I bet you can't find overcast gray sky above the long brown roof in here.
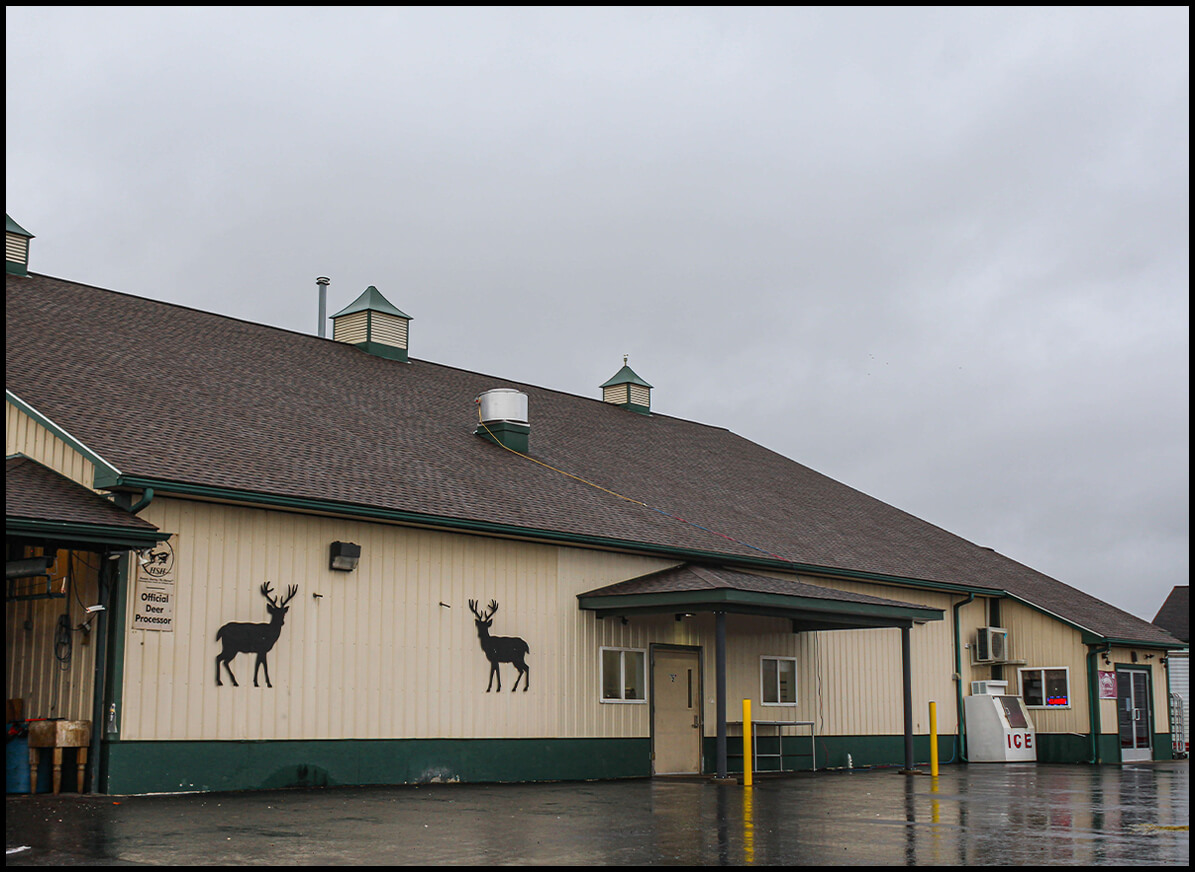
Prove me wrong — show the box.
[6,7,1190,619]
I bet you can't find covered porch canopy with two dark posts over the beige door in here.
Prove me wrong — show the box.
[577,564,943,778]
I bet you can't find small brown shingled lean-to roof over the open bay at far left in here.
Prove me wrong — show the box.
[4,455,165,547]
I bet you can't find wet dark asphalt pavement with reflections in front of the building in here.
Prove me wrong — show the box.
[5,761,1190,866]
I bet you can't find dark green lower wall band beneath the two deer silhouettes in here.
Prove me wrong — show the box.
[103,738,651,794]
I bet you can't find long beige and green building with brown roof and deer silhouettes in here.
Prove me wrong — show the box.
[6,220,1181,793]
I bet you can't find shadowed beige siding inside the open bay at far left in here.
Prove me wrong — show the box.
[5,551,100,720]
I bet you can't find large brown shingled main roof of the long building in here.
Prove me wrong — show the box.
[6,275,1171,644]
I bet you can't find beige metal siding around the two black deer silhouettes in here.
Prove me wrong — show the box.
[122,499,576,738]
